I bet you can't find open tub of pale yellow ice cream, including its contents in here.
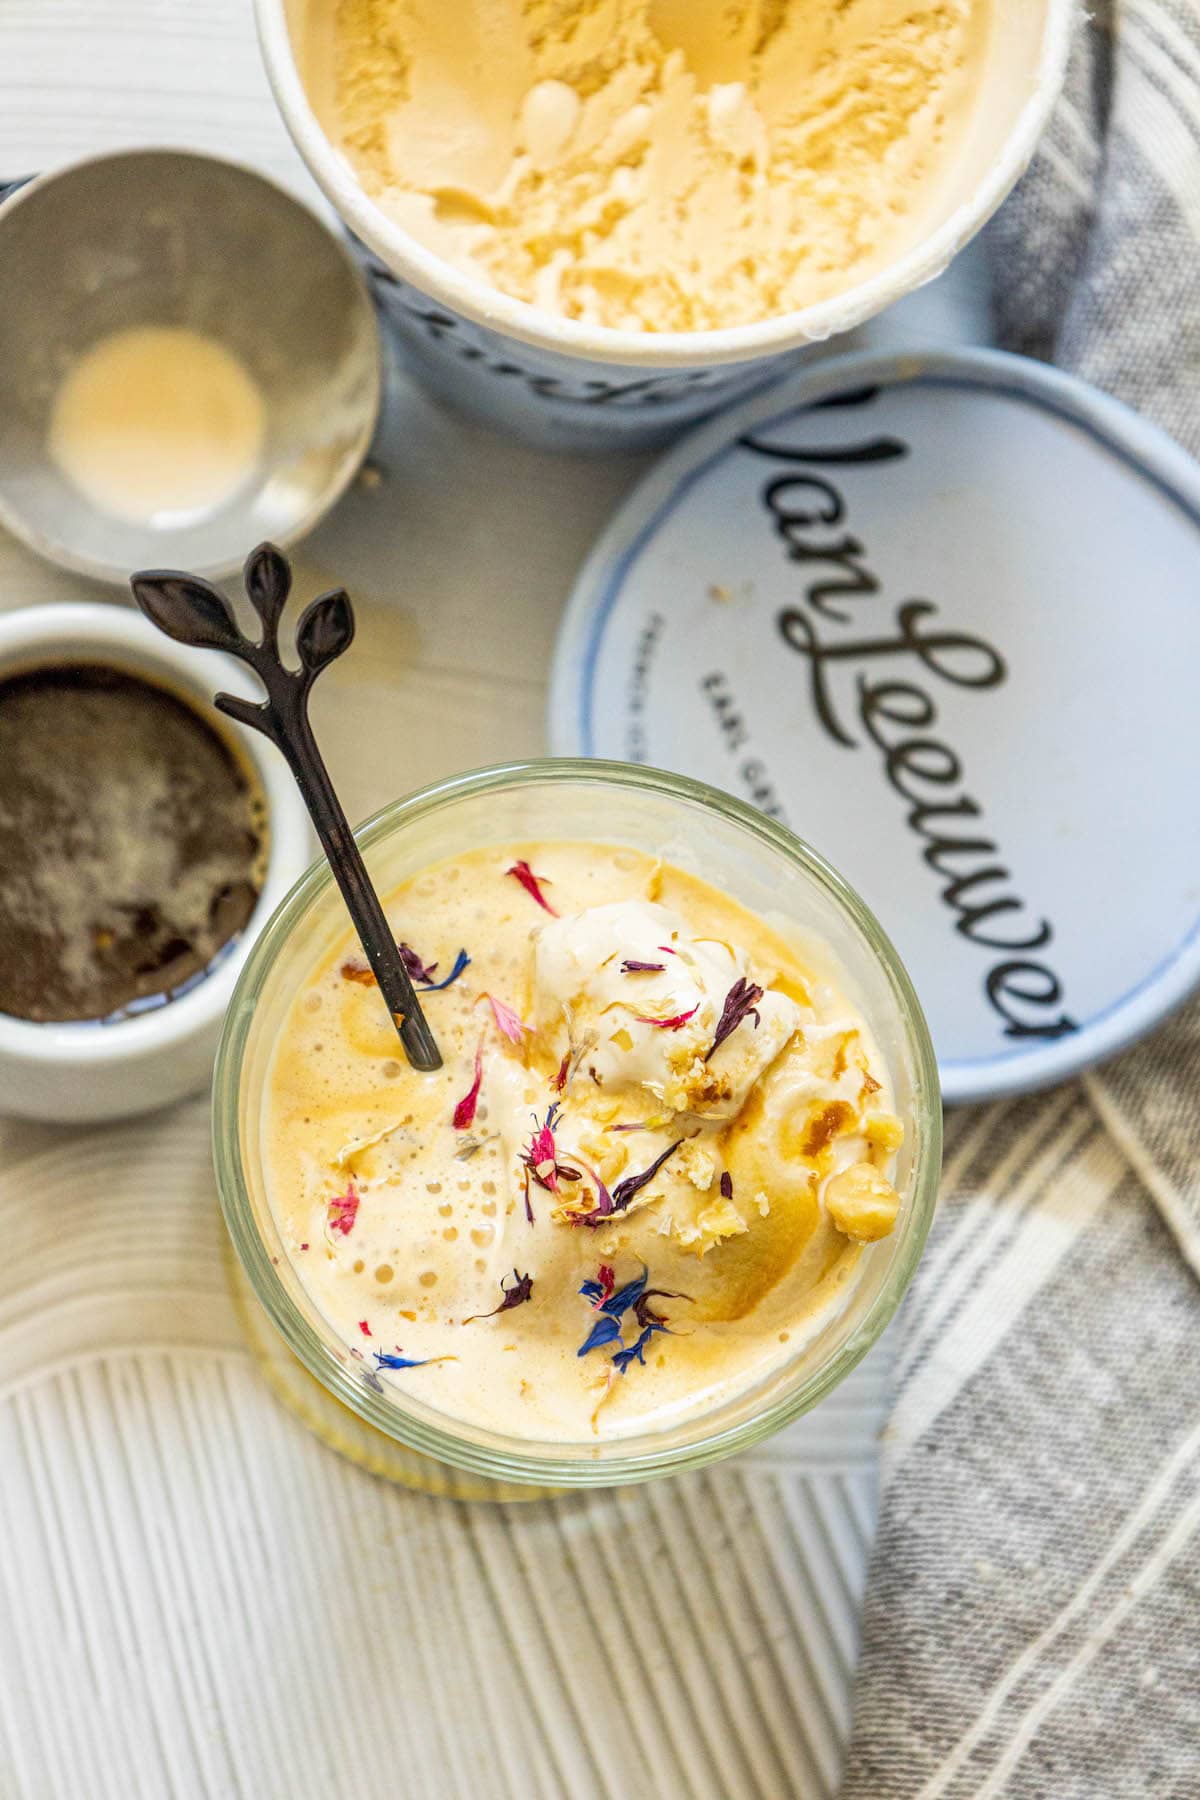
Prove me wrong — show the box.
[255,0,1076,450]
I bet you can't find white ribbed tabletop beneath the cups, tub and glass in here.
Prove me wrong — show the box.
[0,0,986,1800]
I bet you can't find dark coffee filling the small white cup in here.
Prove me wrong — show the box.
[0,662,268,1024]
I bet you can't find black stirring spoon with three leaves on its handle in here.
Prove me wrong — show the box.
[130,544,441,1069]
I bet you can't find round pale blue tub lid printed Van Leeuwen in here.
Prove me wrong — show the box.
[551,338,1200,1100]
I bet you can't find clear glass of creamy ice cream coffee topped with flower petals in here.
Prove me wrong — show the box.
[214,760,941,1492]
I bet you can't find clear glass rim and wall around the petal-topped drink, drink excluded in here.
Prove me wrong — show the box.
[214,760,941,1498]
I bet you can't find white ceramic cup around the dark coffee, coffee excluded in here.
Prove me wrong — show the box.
[0,601,313,1125]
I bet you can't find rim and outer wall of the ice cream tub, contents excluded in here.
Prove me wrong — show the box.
[255,0,1078,450]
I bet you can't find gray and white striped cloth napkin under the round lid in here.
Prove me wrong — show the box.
[842,0,1200,1800]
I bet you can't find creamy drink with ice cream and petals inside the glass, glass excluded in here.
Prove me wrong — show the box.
[263,842,903,1444]
